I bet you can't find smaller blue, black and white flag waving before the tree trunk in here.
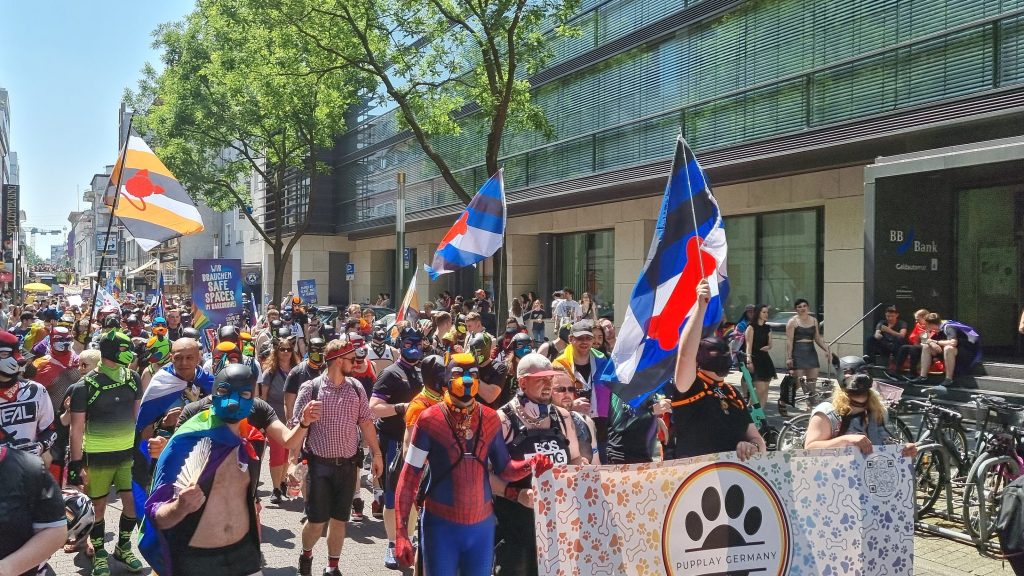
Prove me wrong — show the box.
[426,168,505,280]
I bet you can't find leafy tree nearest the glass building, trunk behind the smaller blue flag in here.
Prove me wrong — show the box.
[268,0,579,323]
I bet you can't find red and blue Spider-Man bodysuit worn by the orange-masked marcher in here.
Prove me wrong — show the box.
[395,398,531,576]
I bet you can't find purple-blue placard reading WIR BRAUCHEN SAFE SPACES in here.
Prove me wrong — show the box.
[193,258,242,344]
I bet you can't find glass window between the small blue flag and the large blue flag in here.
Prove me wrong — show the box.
[554,230,615,315]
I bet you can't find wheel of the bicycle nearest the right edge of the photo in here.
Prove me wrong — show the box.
[963,452,1020,546]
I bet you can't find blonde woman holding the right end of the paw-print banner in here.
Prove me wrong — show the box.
[804,374,918,457]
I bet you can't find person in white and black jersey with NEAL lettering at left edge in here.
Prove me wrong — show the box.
[0,330,56,456]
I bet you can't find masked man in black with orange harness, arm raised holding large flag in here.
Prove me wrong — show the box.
[672,279,767,460]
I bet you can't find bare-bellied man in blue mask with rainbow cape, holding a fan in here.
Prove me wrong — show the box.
[139,364,316,576]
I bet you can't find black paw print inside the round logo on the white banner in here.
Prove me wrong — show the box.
[686,485,762,549]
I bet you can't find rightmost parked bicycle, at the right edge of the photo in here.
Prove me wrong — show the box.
[963,395,1024,549]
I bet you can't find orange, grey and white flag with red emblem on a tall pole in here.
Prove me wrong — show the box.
[103,135,203,250]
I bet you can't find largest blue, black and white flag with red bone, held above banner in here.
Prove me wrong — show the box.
[601,135,729,406]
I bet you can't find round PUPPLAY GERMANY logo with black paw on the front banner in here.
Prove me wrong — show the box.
[659,462,792,576]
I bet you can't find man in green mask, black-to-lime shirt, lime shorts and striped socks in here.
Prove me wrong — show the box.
[68,330,142,576]
